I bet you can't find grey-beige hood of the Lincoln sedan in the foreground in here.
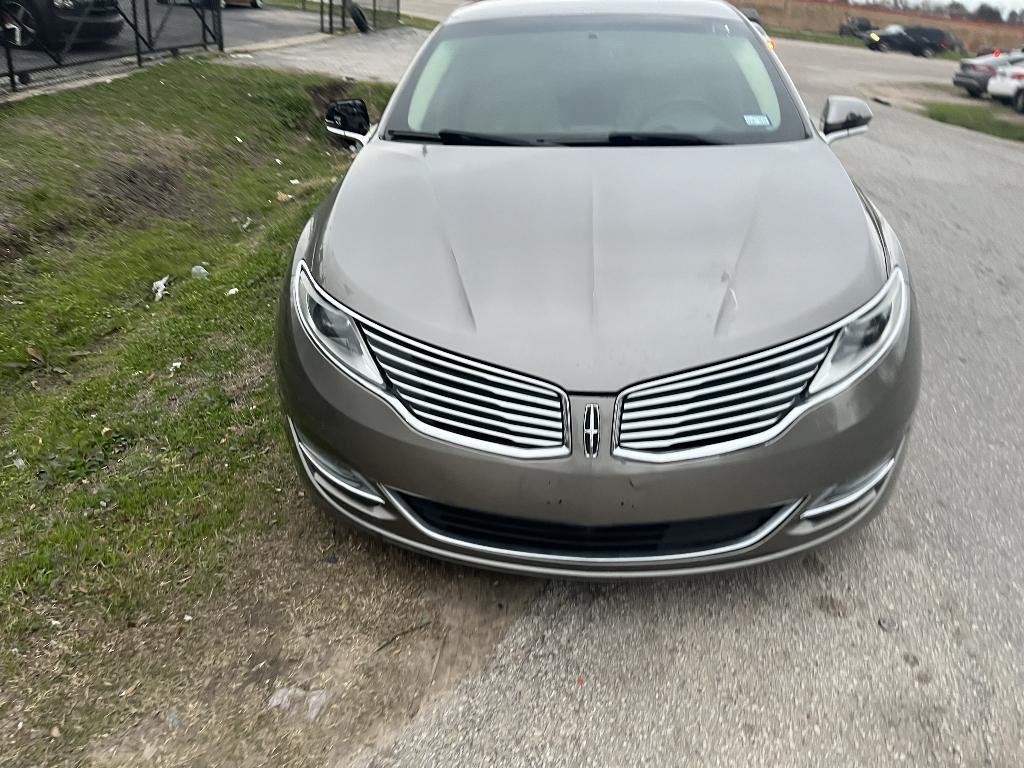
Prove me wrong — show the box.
[309,139,885,392]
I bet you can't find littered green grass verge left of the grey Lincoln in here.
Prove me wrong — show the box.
[0,60,391,764]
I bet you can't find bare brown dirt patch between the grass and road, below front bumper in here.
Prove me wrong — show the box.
[74,492,543,768]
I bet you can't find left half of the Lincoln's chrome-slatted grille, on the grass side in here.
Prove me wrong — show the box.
[361,323,568,458]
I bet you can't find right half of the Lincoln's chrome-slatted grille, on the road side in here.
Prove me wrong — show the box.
[617,329,836,458]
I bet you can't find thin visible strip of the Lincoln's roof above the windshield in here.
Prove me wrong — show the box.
[445,0,741,24]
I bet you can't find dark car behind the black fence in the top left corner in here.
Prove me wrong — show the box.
[0,0,124,49]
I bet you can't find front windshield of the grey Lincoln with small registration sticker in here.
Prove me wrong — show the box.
[383,15,808,144]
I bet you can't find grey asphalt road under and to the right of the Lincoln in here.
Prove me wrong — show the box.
[346,41,1024,768]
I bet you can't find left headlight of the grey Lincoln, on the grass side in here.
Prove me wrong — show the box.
[292,263,384,386]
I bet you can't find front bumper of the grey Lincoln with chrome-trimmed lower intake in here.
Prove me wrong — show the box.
[278,290,920,578]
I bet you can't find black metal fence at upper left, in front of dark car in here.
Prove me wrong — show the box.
[0,0,224,90]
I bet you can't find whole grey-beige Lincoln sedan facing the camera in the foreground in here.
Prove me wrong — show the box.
[288,0,921,579]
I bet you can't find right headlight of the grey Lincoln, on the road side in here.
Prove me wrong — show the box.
[808,268,908,393]
